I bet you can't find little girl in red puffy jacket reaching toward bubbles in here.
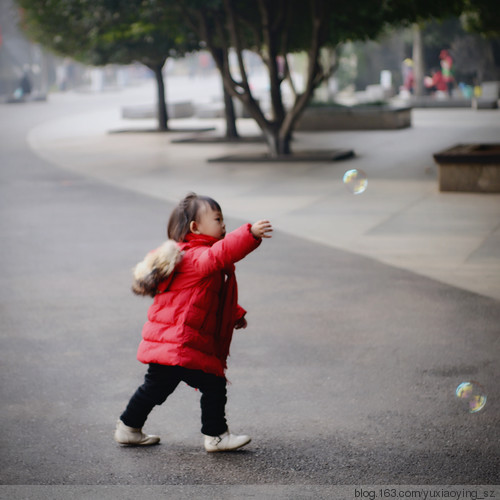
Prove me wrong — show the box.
[115,193,272,452]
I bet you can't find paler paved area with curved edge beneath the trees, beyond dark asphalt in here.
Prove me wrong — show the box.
[29,83,500,300]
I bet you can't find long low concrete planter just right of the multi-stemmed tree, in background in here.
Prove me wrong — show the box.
[296,106,411,131]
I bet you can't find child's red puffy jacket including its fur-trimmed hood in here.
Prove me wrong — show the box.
[133,224,261,376]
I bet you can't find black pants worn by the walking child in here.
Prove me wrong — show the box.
[120,363,227,436]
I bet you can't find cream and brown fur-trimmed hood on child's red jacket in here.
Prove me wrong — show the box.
[132,240,183,297]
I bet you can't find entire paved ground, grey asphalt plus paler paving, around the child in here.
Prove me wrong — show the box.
[0,84,500,499]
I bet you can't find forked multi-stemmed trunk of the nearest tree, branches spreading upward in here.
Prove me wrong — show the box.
[188,0,327,158]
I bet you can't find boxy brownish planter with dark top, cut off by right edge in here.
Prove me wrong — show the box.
[434,144,500,193]
